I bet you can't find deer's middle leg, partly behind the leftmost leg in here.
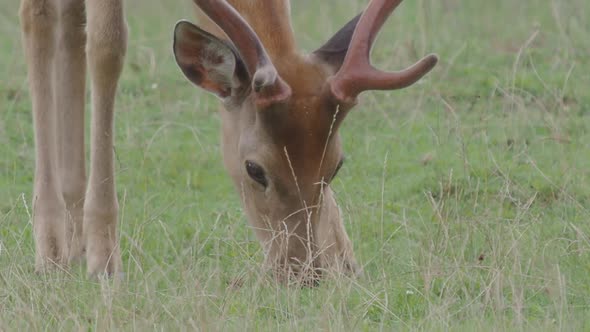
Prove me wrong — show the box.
[55,0,86,262]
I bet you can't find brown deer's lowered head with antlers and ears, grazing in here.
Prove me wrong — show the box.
[174,0,437,277]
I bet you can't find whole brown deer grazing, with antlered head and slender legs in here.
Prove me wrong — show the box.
[21,0,437,280]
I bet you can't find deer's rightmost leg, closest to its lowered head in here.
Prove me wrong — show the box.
[84,0,127,275]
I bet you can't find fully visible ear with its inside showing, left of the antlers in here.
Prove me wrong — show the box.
[174,21,247,99]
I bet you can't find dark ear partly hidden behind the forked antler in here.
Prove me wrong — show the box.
[313,13,362,72]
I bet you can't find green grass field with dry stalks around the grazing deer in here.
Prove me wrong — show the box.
[0,0,590,331]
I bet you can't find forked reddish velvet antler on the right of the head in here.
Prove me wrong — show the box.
[328,0,438,103]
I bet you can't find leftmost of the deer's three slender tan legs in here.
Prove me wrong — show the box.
[20,0,67,271]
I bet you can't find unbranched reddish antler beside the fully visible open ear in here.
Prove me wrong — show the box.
[193,0,291,108]
